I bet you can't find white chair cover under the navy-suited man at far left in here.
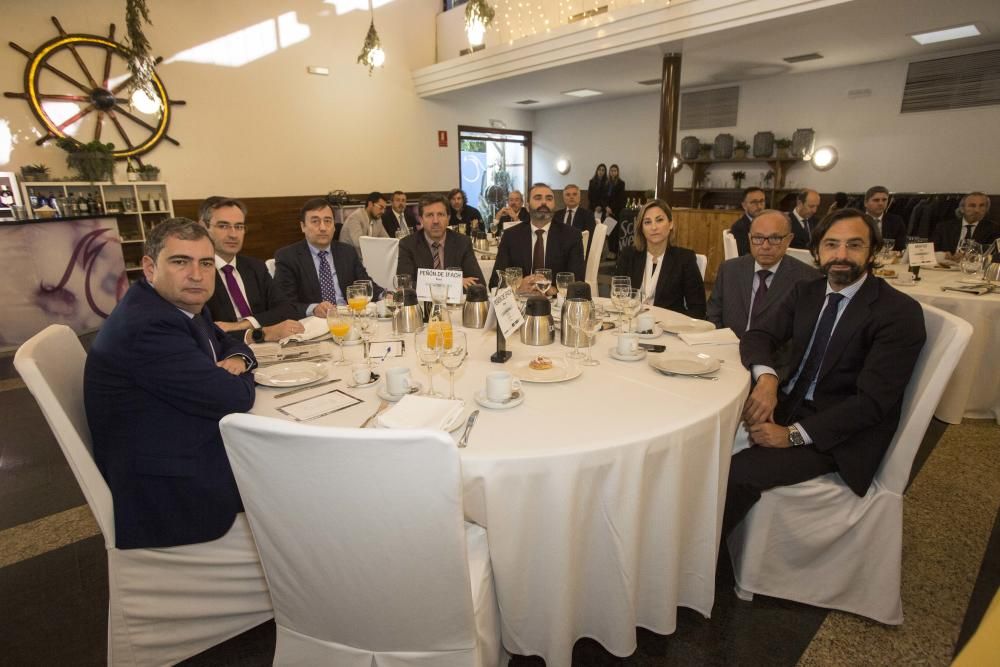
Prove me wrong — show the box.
[14,324,272,665]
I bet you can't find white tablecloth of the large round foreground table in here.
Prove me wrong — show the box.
[252,308,750,667]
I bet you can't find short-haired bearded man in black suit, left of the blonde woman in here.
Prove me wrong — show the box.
[490,183,586,290]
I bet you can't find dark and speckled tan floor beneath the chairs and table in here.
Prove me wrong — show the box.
[0,342,1000,666]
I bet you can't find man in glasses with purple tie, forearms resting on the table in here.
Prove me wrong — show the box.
[198,197,304,343]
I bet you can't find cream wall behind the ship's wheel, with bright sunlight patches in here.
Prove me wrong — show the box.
[0,0,533,198]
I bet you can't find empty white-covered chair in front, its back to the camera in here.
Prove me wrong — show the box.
[220,414,502,667]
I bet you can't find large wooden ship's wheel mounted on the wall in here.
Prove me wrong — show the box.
[4,16,185,159]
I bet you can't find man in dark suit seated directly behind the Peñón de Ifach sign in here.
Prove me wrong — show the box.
[396,194,486,287]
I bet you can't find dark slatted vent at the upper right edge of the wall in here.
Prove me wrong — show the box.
[900,49,1000,113]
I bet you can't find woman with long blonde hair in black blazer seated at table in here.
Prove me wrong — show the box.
[615,199,705,319]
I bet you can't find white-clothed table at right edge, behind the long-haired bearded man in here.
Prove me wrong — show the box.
[887,267,1000,424]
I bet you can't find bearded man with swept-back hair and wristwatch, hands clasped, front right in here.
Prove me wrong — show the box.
[723,209,926,534]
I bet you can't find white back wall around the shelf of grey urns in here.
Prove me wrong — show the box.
[534,56,1000,192]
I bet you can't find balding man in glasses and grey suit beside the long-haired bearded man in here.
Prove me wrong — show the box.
[708,209,820,338]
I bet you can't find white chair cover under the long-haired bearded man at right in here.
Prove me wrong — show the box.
[728,305,972,625]
